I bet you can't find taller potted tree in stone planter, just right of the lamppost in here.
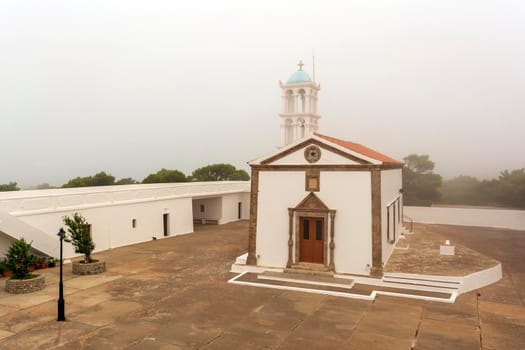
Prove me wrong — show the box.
[64,213,106,275]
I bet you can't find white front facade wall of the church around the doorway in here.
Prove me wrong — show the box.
[256,171,372,274]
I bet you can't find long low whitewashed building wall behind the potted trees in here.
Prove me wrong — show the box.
[0,181,250,257]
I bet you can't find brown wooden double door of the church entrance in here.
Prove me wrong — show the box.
[299,216,325,264]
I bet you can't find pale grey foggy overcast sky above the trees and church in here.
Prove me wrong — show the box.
[0,0,525,186]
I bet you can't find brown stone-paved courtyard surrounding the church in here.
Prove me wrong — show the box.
[0,221,525,350]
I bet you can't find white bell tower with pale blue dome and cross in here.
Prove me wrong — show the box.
[279,61,321,146]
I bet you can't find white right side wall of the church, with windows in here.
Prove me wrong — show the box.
[381,169,403,263]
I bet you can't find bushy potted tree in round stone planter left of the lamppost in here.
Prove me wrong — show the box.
[5,238,45,294]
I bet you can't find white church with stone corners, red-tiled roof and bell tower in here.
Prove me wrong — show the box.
[246,62,403,277]
